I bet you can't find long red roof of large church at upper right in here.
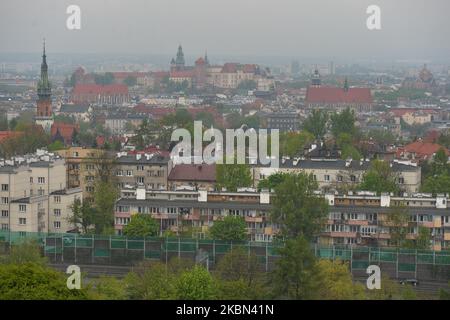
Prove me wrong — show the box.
[306,87,373,103]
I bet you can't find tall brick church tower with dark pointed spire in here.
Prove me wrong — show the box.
[35,41,53,132]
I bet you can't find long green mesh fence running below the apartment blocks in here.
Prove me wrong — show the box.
[0,231,450,279]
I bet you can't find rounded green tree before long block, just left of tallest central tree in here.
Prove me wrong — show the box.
[209,216,247,241]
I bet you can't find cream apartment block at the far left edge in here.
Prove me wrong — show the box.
[0,150,82,232]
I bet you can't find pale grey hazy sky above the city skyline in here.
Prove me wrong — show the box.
[0,0,450,59]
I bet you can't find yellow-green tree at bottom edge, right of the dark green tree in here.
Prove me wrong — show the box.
[313,259,365,300]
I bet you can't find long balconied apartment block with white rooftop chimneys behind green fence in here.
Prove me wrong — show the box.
[115,188,450,250]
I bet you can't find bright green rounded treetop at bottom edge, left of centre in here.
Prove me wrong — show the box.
[175,266,217,300]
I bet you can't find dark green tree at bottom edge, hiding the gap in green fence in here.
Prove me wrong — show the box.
[271,236,316,300]
